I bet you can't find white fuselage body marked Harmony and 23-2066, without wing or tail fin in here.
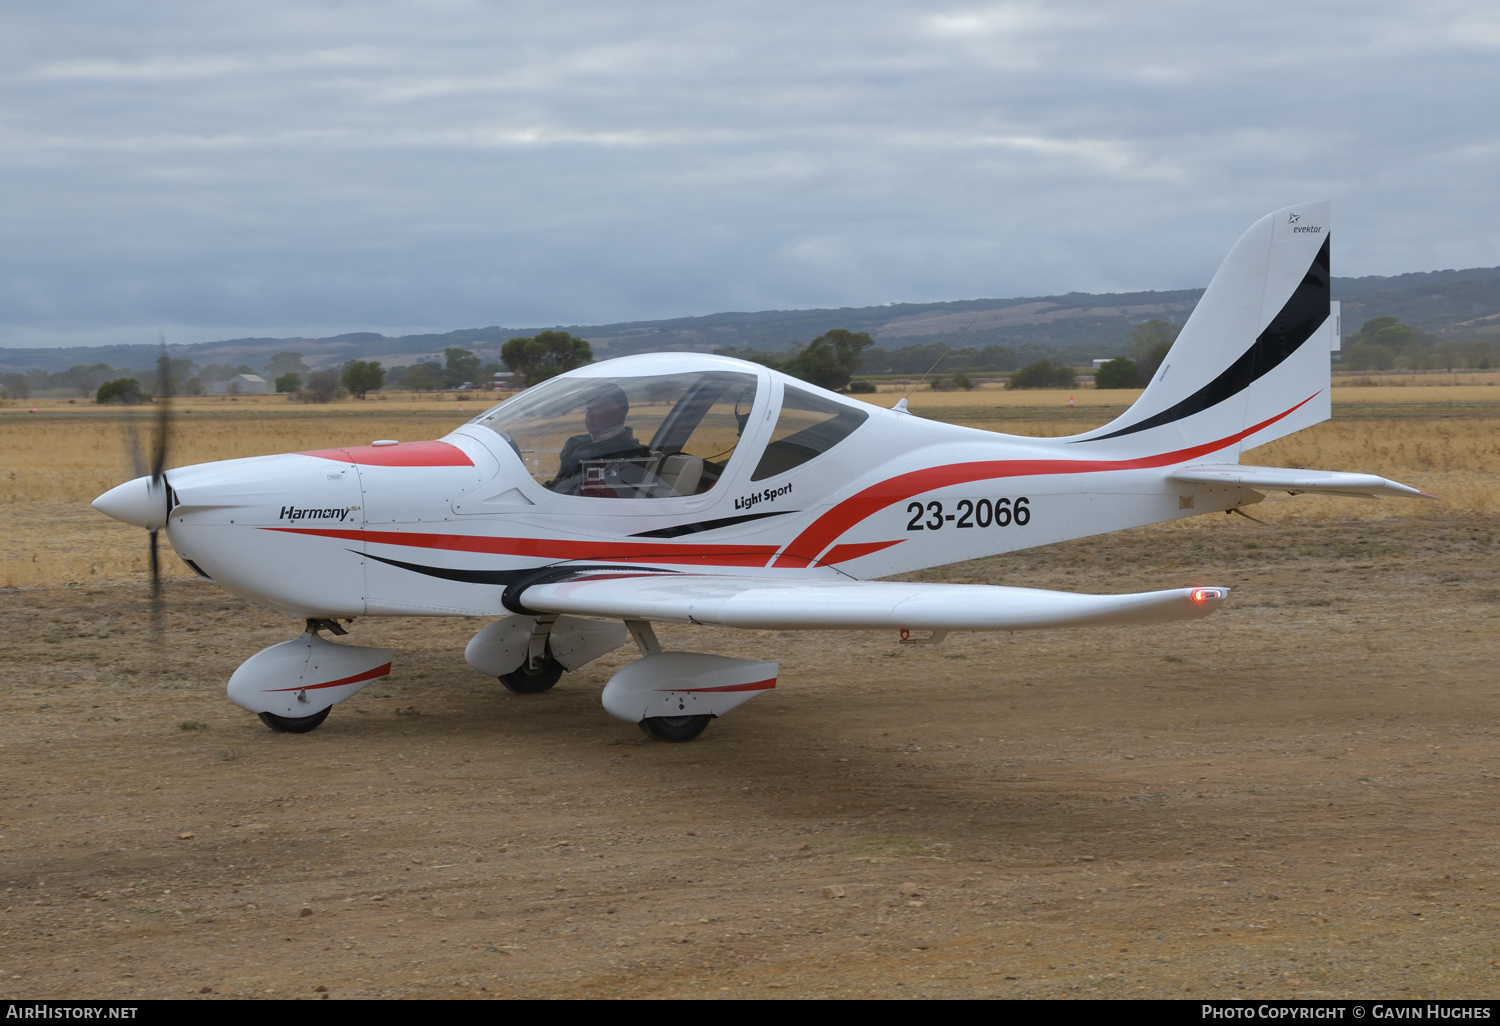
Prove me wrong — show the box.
[143,354,1242,617]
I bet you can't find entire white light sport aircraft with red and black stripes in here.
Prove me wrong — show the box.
[95,203,1424,741]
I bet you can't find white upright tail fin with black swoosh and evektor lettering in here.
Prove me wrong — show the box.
[1070,201,1335,461]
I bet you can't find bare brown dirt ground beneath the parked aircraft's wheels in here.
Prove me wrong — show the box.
[0,504,1500,999]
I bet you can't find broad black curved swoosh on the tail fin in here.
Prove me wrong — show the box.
[1077,236,1332,441]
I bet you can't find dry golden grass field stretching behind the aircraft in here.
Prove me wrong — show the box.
[0,386,1500,588]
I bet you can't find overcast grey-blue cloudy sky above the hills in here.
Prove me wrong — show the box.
[0,0,1500,347]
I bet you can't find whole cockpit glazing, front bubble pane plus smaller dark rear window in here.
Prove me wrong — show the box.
[470,357,869,498]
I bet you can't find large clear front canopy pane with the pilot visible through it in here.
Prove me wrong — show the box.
[470,371,756,498]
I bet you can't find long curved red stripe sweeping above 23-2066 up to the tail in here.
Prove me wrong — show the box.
[771,390,1322,567]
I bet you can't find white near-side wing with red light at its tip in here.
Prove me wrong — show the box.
[512,569,1229,630]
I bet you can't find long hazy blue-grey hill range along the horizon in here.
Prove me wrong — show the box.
[0,267,1500,372]
